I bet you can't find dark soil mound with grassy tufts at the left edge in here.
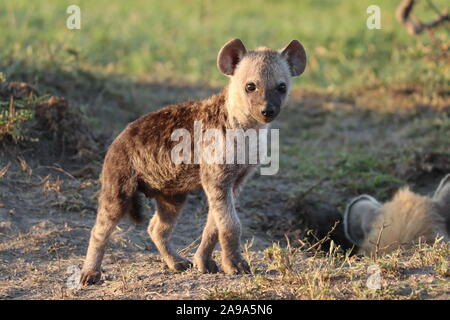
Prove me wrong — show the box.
[0,82,104,161]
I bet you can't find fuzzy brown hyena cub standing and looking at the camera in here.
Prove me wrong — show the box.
[80,39,306,284]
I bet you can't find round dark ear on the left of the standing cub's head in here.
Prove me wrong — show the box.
[217,39,247,76]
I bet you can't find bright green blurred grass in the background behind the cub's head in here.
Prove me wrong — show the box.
[0,0,450,91]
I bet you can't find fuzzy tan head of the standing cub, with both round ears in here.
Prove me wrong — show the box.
[217,39,306,123]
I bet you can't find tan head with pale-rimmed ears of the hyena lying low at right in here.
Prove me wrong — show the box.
[344,175,450,255]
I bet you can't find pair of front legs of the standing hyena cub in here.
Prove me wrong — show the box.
[196,178,250,274]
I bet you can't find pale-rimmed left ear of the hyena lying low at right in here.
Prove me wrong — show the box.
[344,195,382,246]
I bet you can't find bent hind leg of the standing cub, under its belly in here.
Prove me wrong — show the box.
[148,194,192,271]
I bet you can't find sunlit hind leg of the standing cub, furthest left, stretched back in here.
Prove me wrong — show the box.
[80,190,137,285]
